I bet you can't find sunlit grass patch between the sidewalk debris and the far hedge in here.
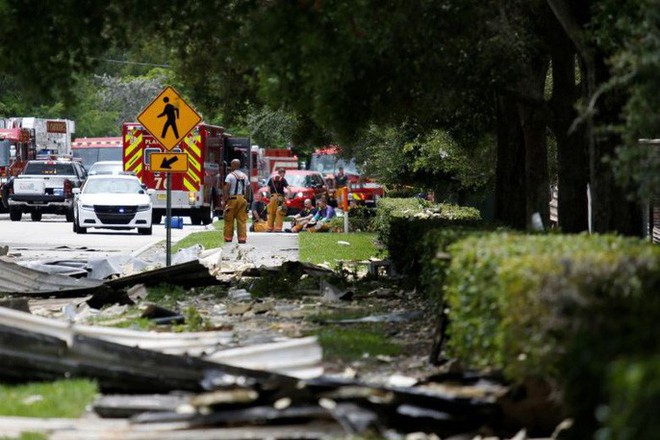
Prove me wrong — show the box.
[299,232,379,267]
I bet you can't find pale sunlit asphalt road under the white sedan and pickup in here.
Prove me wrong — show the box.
[0,213,209,260]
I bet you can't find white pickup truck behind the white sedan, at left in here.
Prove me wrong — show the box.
[9,160,87,222]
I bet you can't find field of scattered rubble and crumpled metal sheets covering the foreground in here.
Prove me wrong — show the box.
[0,247,560,440]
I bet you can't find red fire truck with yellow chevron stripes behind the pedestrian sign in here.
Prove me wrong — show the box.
[122,122,251,225]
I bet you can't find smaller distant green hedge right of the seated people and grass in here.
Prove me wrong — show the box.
[374,198,481,277]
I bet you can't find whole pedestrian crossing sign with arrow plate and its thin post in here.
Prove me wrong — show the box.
[137,87,202,267]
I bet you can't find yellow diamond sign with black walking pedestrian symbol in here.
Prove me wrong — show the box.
[138,87,202,150]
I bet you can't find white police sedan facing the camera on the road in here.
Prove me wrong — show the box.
[73,174,152,235]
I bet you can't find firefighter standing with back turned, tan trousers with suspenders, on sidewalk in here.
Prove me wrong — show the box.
[222,159,248,243]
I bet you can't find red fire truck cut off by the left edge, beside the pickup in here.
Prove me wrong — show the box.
[0,128,36,210]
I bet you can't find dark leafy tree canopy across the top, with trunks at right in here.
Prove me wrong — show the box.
[0,0,660,233]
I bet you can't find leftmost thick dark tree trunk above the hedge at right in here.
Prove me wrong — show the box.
[495,95,526,229]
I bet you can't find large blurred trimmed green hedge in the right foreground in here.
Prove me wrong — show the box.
[439,233,660,438]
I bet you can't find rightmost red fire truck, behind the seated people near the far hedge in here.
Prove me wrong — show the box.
[309,145,385,206]
